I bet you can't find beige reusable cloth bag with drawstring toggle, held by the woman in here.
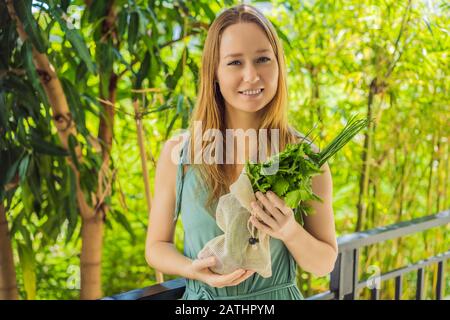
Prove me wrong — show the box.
[197,168,272,278]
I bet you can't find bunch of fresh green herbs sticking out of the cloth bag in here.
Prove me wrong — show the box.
[246,116,369,225]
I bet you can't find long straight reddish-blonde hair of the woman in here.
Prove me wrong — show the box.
[189,5,297,211]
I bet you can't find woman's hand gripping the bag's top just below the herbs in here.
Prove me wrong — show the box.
[250,191,299,242]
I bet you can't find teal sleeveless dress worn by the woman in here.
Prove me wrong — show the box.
[174,139,303,300]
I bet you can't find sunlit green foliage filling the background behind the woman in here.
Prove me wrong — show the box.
[0,0,450,299]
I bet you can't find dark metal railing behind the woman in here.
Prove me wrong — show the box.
[103,210,450,300]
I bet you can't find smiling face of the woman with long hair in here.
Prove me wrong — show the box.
[217,23,278,112]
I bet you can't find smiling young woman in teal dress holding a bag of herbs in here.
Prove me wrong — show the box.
[146,5,337,299]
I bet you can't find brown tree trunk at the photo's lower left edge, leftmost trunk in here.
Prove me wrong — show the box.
[0,202,19,300]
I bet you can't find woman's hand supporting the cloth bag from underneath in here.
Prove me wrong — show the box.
[190,257,255,288]
